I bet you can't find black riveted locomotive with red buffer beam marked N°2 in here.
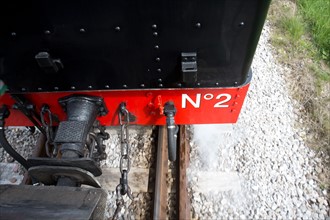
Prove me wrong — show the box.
[0,0,270,218]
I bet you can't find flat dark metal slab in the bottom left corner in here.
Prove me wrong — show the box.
[0,185,107,220]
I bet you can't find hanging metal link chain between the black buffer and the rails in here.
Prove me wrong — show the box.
[112,103,133,220]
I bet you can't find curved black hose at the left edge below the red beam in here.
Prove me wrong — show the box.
[0,105,30,170]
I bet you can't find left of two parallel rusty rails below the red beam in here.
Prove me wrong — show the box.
[153,126,168,220]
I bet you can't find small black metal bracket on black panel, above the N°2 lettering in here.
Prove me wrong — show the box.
[181,52,197,84]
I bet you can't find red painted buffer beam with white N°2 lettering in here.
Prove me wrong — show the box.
[0,84,249,126]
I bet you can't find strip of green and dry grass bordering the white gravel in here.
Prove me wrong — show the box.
[268,0,330,189]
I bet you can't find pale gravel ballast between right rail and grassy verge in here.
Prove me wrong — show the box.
[189,24,329,219]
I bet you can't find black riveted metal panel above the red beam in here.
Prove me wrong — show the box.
[0,0,270,92]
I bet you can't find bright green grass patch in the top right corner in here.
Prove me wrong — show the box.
[297,0,330,63]
